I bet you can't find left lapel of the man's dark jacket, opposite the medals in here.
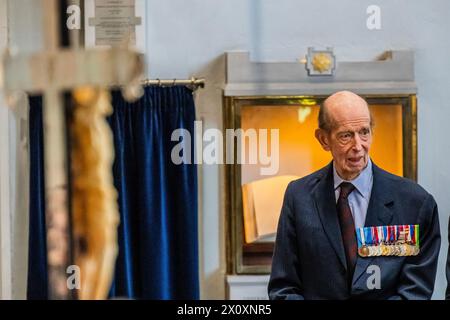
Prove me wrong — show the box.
[313,163,347,269]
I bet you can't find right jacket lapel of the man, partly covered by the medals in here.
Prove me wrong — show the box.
[353,163,394,284]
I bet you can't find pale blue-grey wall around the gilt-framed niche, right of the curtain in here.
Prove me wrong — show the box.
[143,0,450,298]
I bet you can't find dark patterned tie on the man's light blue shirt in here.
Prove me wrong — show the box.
[337,182,358,287]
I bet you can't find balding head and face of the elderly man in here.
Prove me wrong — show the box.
[319,92,372,180]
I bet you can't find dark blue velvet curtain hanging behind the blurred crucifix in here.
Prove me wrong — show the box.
[28,86,199,299]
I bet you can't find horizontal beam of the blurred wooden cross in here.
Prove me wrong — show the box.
[0,48,143,94]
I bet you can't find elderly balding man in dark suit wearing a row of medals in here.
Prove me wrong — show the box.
[268,91,441,299]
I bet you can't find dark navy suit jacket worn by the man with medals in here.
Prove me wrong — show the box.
[268,164,441,299]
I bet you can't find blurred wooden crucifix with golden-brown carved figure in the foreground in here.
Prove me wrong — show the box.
[0,0,144,299]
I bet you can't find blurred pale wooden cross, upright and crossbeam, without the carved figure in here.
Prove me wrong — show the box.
[0,0,144,299]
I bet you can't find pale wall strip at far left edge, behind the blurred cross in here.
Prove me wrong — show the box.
[0,0,42,299]
